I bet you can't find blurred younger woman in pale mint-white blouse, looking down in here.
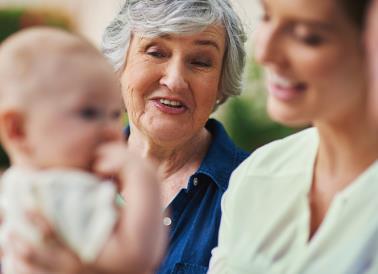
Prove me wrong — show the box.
[209,0,378,274]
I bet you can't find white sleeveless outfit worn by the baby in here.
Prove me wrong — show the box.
[0,167,117,273]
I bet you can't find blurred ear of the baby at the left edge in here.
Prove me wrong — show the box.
[0,110,26,146]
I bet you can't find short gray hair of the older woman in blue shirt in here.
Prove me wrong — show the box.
[102,0,246,104]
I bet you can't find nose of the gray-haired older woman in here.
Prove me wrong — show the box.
[160,58,189,91]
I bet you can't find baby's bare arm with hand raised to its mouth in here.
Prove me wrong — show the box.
[90,143,166,273]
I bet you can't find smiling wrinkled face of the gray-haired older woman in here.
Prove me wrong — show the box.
[121,26,225,144]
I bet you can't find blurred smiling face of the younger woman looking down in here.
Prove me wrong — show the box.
[255,0,366,125]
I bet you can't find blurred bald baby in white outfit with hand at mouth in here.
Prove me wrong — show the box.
[0,27,165,274]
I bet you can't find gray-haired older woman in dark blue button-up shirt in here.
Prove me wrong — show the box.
[6,0,247,274]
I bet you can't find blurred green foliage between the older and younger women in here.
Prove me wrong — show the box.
[215,60,297,151]
